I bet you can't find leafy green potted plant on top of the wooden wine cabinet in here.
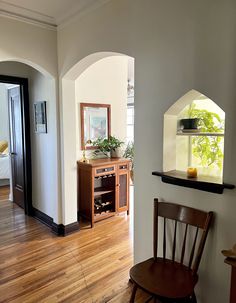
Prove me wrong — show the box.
[92,136,124,158]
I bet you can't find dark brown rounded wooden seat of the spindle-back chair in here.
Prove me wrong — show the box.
[130,258,198,299]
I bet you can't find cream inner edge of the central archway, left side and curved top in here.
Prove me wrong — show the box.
[60,52,135,225]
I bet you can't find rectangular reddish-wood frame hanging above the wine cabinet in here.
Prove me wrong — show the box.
[80,103,111,149]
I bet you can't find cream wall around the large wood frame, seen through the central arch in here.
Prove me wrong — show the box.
[75,56,128,160]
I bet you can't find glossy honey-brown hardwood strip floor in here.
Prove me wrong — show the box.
[0,194,147,303]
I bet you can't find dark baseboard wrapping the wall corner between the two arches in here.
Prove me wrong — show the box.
[32,207,79,236]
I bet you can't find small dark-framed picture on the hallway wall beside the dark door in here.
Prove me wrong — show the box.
[34,101,47,133]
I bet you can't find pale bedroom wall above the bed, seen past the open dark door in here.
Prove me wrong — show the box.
[0,83,9,142]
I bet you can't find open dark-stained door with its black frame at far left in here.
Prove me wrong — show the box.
[0,75,32,215]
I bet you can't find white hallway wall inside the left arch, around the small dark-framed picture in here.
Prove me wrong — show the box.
[0,62,61,223]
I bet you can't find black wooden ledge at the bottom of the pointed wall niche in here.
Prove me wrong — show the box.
[152,170,235,194]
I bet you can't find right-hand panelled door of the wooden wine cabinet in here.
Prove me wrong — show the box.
[117,170,129,212]
